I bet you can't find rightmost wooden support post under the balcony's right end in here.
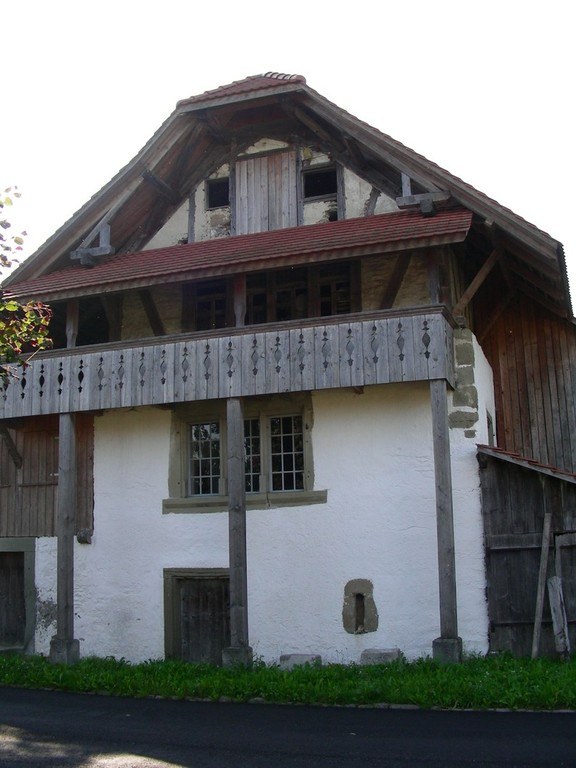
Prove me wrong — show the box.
[430,379,462,662]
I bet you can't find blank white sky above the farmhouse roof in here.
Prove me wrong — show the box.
[0,0,576,296]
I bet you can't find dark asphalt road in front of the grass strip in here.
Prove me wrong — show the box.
[0,687,576,768]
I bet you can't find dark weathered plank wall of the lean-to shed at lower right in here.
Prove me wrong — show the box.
[479,454,576,656]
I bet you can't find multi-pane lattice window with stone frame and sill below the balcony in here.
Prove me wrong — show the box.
[164,394,326,512]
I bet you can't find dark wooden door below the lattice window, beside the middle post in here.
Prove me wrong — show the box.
[179,576,230,665]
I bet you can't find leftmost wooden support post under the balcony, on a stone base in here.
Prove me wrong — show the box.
[50,413,80,664]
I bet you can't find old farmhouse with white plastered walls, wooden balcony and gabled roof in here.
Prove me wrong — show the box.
[0,73,576,663]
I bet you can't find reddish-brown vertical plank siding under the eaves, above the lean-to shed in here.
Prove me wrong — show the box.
[482,297,576,472]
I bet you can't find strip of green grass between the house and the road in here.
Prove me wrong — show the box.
[0,656,576,710]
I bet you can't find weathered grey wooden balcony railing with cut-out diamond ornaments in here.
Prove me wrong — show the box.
[0,306,454,419]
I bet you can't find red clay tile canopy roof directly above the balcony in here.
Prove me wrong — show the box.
[5,208,472,300]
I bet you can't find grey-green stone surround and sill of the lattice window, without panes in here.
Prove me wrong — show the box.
[162,393,327,514]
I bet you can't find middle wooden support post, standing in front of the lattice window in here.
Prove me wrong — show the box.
[222,397,252,666]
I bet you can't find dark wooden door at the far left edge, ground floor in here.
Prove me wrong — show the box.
[0,552,26,648]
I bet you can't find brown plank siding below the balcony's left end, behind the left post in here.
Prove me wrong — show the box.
[0,414,94,537]
